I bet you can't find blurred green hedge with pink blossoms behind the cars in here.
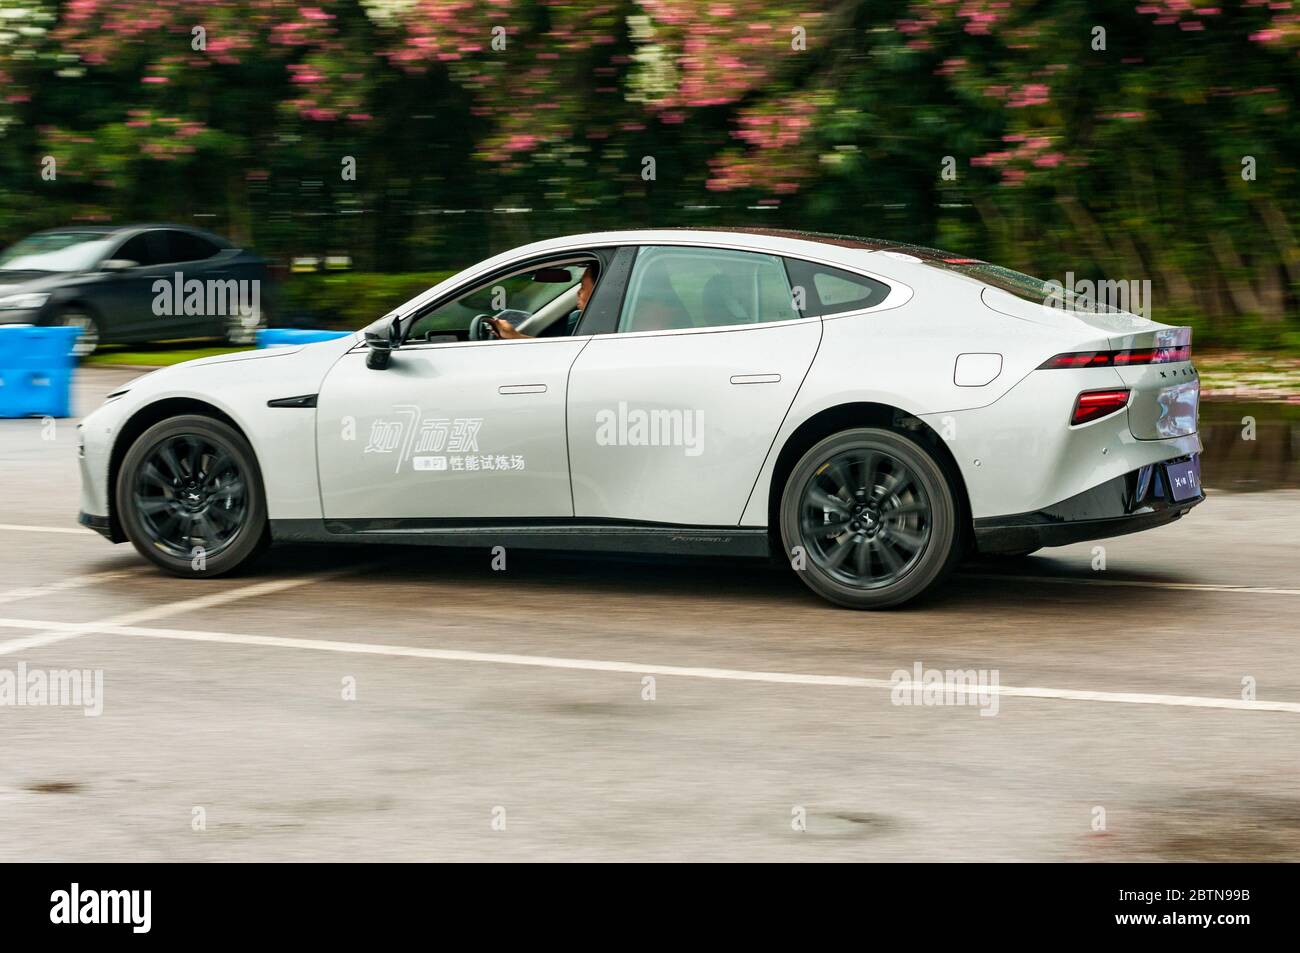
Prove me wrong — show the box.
[0,0,1300,351]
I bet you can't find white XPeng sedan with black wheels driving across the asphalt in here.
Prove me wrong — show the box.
[81,229,1204,608]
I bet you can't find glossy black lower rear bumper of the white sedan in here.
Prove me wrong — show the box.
[975,454,1205,553]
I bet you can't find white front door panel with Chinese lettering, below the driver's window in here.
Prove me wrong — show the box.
[316,338,586,520]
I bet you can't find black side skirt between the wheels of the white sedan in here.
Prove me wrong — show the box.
[270,519,771,558]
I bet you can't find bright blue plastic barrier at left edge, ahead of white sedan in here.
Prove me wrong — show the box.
[0,324,81,417]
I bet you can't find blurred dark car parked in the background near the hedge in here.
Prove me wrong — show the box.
[0,225,268,356]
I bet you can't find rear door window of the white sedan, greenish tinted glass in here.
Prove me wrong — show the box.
[619,246,800,333]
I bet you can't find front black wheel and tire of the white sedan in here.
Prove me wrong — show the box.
[113,415,270,579]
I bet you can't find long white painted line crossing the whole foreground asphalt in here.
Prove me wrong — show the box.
[0,619,1300,714]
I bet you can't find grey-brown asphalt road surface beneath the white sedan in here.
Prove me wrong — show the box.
[0,371,1300,861]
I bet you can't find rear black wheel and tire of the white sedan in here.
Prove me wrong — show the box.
[780,428,963,608]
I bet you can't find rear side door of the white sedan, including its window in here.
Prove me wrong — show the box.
[568,246,822,527]
